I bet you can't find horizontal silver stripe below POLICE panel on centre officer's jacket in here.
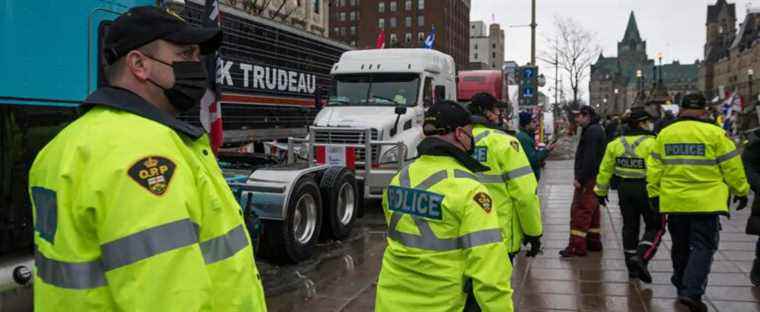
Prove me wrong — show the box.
[388,224,502,251]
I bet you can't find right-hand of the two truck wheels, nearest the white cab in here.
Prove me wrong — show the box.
[320,167,359,239]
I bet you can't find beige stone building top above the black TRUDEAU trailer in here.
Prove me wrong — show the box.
[219,0,330,37]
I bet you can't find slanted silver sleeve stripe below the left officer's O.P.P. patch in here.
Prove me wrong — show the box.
[100,219,198,271]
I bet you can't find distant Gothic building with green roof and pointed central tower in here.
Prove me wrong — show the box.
[589,12,699,115]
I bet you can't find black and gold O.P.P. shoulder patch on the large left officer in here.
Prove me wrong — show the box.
[127,156,177,196]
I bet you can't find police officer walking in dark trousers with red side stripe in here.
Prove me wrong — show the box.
[594,110,665,283]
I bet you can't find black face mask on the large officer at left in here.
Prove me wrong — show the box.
[148,56,208,113]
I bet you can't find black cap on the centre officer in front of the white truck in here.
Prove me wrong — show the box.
[422,101,472,135]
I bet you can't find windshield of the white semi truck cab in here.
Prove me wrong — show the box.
[329,74,420,106]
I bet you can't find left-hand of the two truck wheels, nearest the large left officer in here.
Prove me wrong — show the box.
[260,177,322,263]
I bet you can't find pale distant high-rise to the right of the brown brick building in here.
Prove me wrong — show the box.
[468,21,505,70]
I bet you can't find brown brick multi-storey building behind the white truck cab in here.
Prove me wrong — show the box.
[330,0,470,68]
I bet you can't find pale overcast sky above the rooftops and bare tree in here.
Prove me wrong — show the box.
[470,0,760,101]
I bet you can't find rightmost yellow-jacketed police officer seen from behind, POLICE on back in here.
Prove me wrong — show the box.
[647,93,749,311]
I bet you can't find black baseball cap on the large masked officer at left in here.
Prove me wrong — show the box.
[103,6,222,65]
